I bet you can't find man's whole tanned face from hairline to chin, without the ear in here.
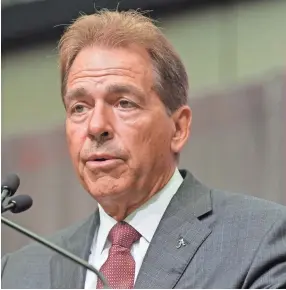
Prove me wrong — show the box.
[64,46,190,204]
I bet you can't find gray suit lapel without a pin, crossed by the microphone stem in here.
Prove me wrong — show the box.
[50,211,99,289]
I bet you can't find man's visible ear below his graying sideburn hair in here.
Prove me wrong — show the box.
[171,105,192,154]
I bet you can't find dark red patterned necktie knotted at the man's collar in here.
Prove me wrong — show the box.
[96,222,141,289]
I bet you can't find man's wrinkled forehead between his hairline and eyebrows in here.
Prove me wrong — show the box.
[64,47,154,99]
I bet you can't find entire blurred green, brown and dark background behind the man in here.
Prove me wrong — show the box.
[1,0,286,254]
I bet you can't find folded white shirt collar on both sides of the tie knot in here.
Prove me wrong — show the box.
[97,168,183,253]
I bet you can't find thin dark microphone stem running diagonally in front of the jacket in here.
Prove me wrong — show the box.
[1,216,109,289]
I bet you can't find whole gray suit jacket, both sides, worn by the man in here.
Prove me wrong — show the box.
[2,171,286,289]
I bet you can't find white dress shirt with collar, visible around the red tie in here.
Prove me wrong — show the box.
[85,168,183,289]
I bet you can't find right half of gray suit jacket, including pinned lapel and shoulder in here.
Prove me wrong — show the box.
[135,171,286,289]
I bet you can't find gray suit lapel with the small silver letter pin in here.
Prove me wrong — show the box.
[134,171,212,289]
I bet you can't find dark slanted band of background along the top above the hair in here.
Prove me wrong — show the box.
[2,0,258,53]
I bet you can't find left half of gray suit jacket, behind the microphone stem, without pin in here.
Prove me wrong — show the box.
[1,214,97,289]
